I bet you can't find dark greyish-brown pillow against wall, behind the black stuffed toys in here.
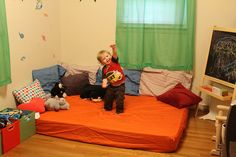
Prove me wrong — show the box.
[61,72,89,96]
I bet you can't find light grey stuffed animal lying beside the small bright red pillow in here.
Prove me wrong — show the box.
[45,96,70,111]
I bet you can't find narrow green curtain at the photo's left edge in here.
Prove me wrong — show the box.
[0,0,11,86]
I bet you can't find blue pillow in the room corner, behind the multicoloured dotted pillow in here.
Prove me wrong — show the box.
[32,65,66,93]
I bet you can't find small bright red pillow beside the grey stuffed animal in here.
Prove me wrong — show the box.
[17,98,45,113]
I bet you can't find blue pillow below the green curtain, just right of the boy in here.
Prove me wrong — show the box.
[124,69,141,95]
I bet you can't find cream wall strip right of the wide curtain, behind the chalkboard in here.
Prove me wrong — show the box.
[193,0,236,91]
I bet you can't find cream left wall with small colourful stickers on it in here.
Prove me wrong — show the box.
[0,0,60,109]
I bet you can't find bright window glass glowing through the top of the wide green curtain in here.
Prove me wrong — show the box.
[123,0,187,25]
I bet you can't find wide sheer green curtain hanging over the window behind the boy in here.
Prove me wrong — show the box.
[116,0,196,70]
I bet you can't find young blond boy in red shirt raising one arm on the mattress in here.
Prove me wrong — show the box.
[97,45,125,114]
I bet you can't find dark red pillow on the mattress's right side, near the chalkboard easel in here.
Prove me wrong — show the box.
[157,83,202,108]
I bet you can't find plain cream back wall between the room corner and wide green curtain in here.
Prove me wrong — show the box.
[60,0,116,65]
